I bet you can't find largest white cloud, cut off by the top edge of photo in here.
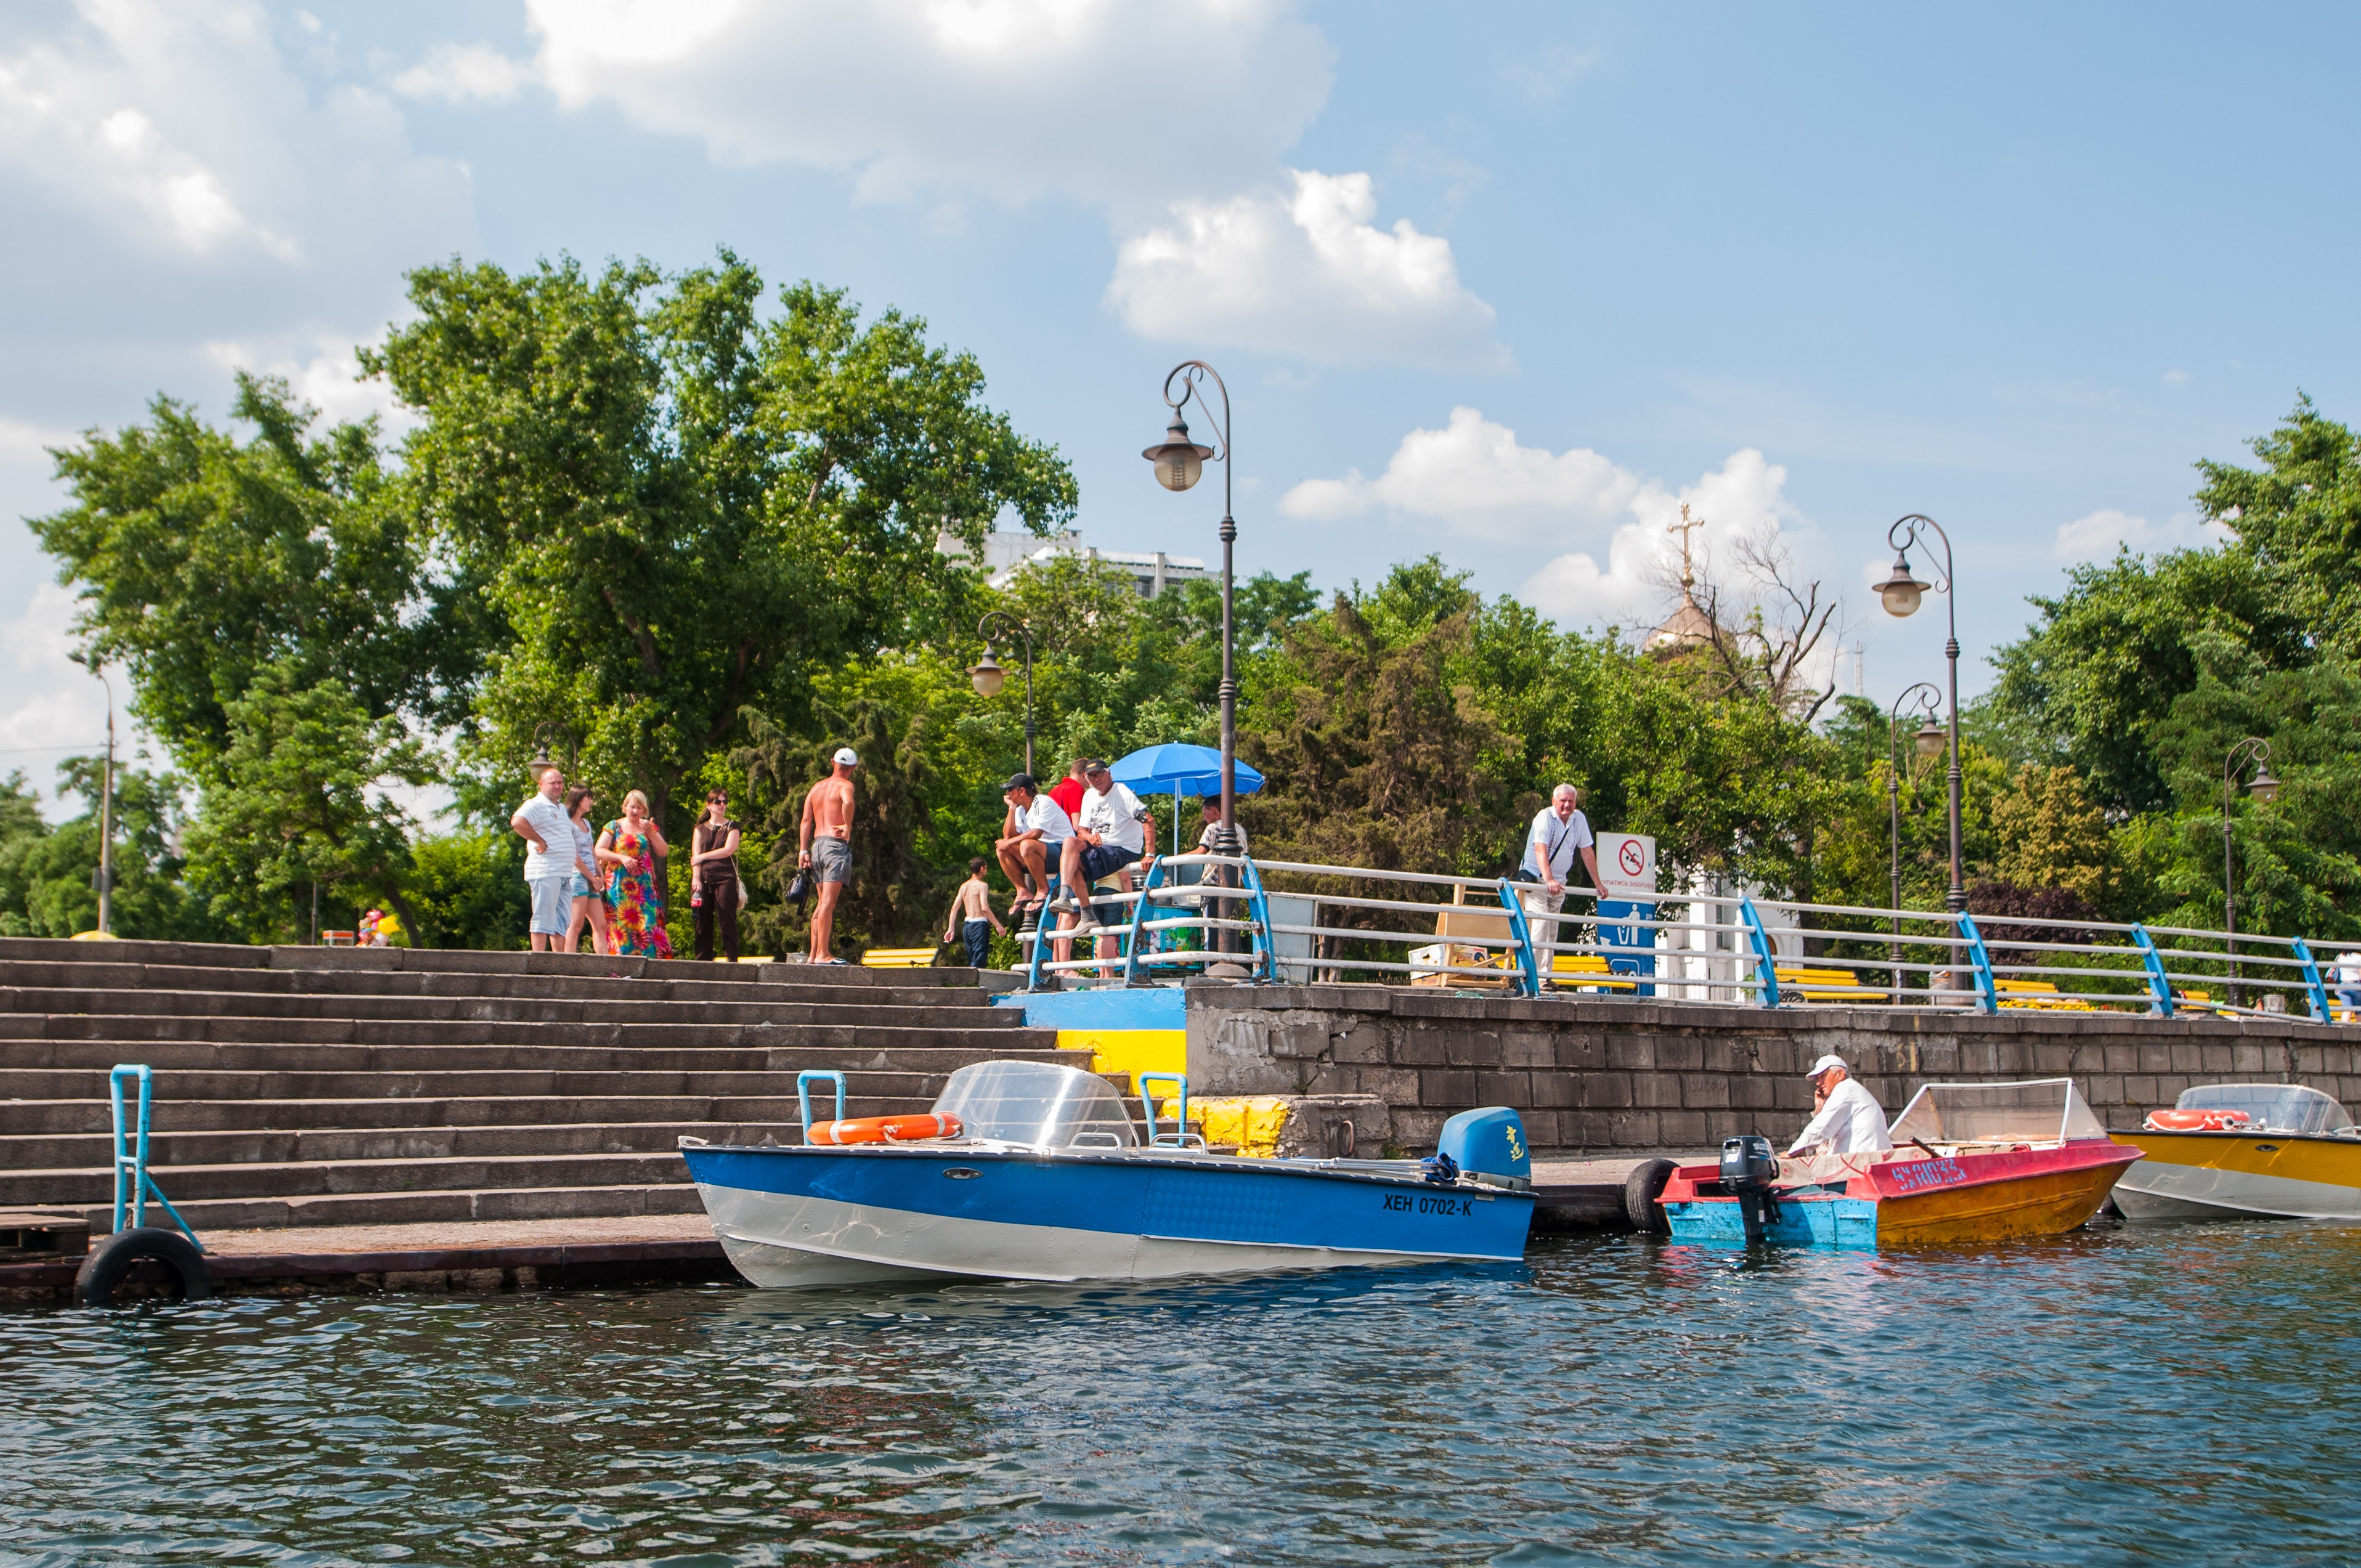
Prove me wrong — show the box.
[527,0,1329,210]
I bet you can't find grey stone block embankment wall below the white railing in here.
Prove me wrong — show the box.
[1187,985,2361,1152]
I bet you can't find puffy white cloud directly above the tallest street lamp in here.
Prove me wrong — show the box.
[1107,170,1511,371]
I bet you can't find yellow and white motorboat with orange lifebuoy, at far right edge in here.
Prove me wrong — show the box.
[2113,1084,2361,1219]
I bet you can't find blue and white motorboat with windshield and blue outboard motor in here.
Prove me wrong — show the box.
[680,1060,1532,1287]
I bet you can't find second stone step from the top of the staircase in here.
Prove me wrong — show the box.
[0,961,991,1009]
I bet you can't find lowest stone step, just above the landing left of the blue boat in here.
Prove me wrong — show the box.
[0,1134,701,1207]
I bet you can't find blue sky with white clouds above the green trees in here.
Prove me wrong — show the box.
[0,0,2361,803]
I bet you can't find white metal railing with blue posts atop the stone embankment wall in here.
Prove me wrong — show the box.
[1020,855,2361,1023]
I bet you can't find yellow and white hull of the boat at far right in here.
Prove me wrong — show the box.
[2113,1131,2361,1219]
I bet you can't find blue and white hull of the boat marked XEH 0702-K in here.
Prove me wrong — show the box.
[682,1145,1532,1285]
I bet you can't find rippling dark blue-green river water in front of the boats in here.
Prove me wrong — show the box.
[0,1225,2361,1568]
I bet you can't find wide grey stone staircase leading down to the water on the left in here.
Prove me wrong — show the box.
[0,938,1089,1233]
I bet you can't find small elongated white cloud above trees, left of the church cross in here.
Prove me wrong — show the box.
[1280,408,1643,541]
